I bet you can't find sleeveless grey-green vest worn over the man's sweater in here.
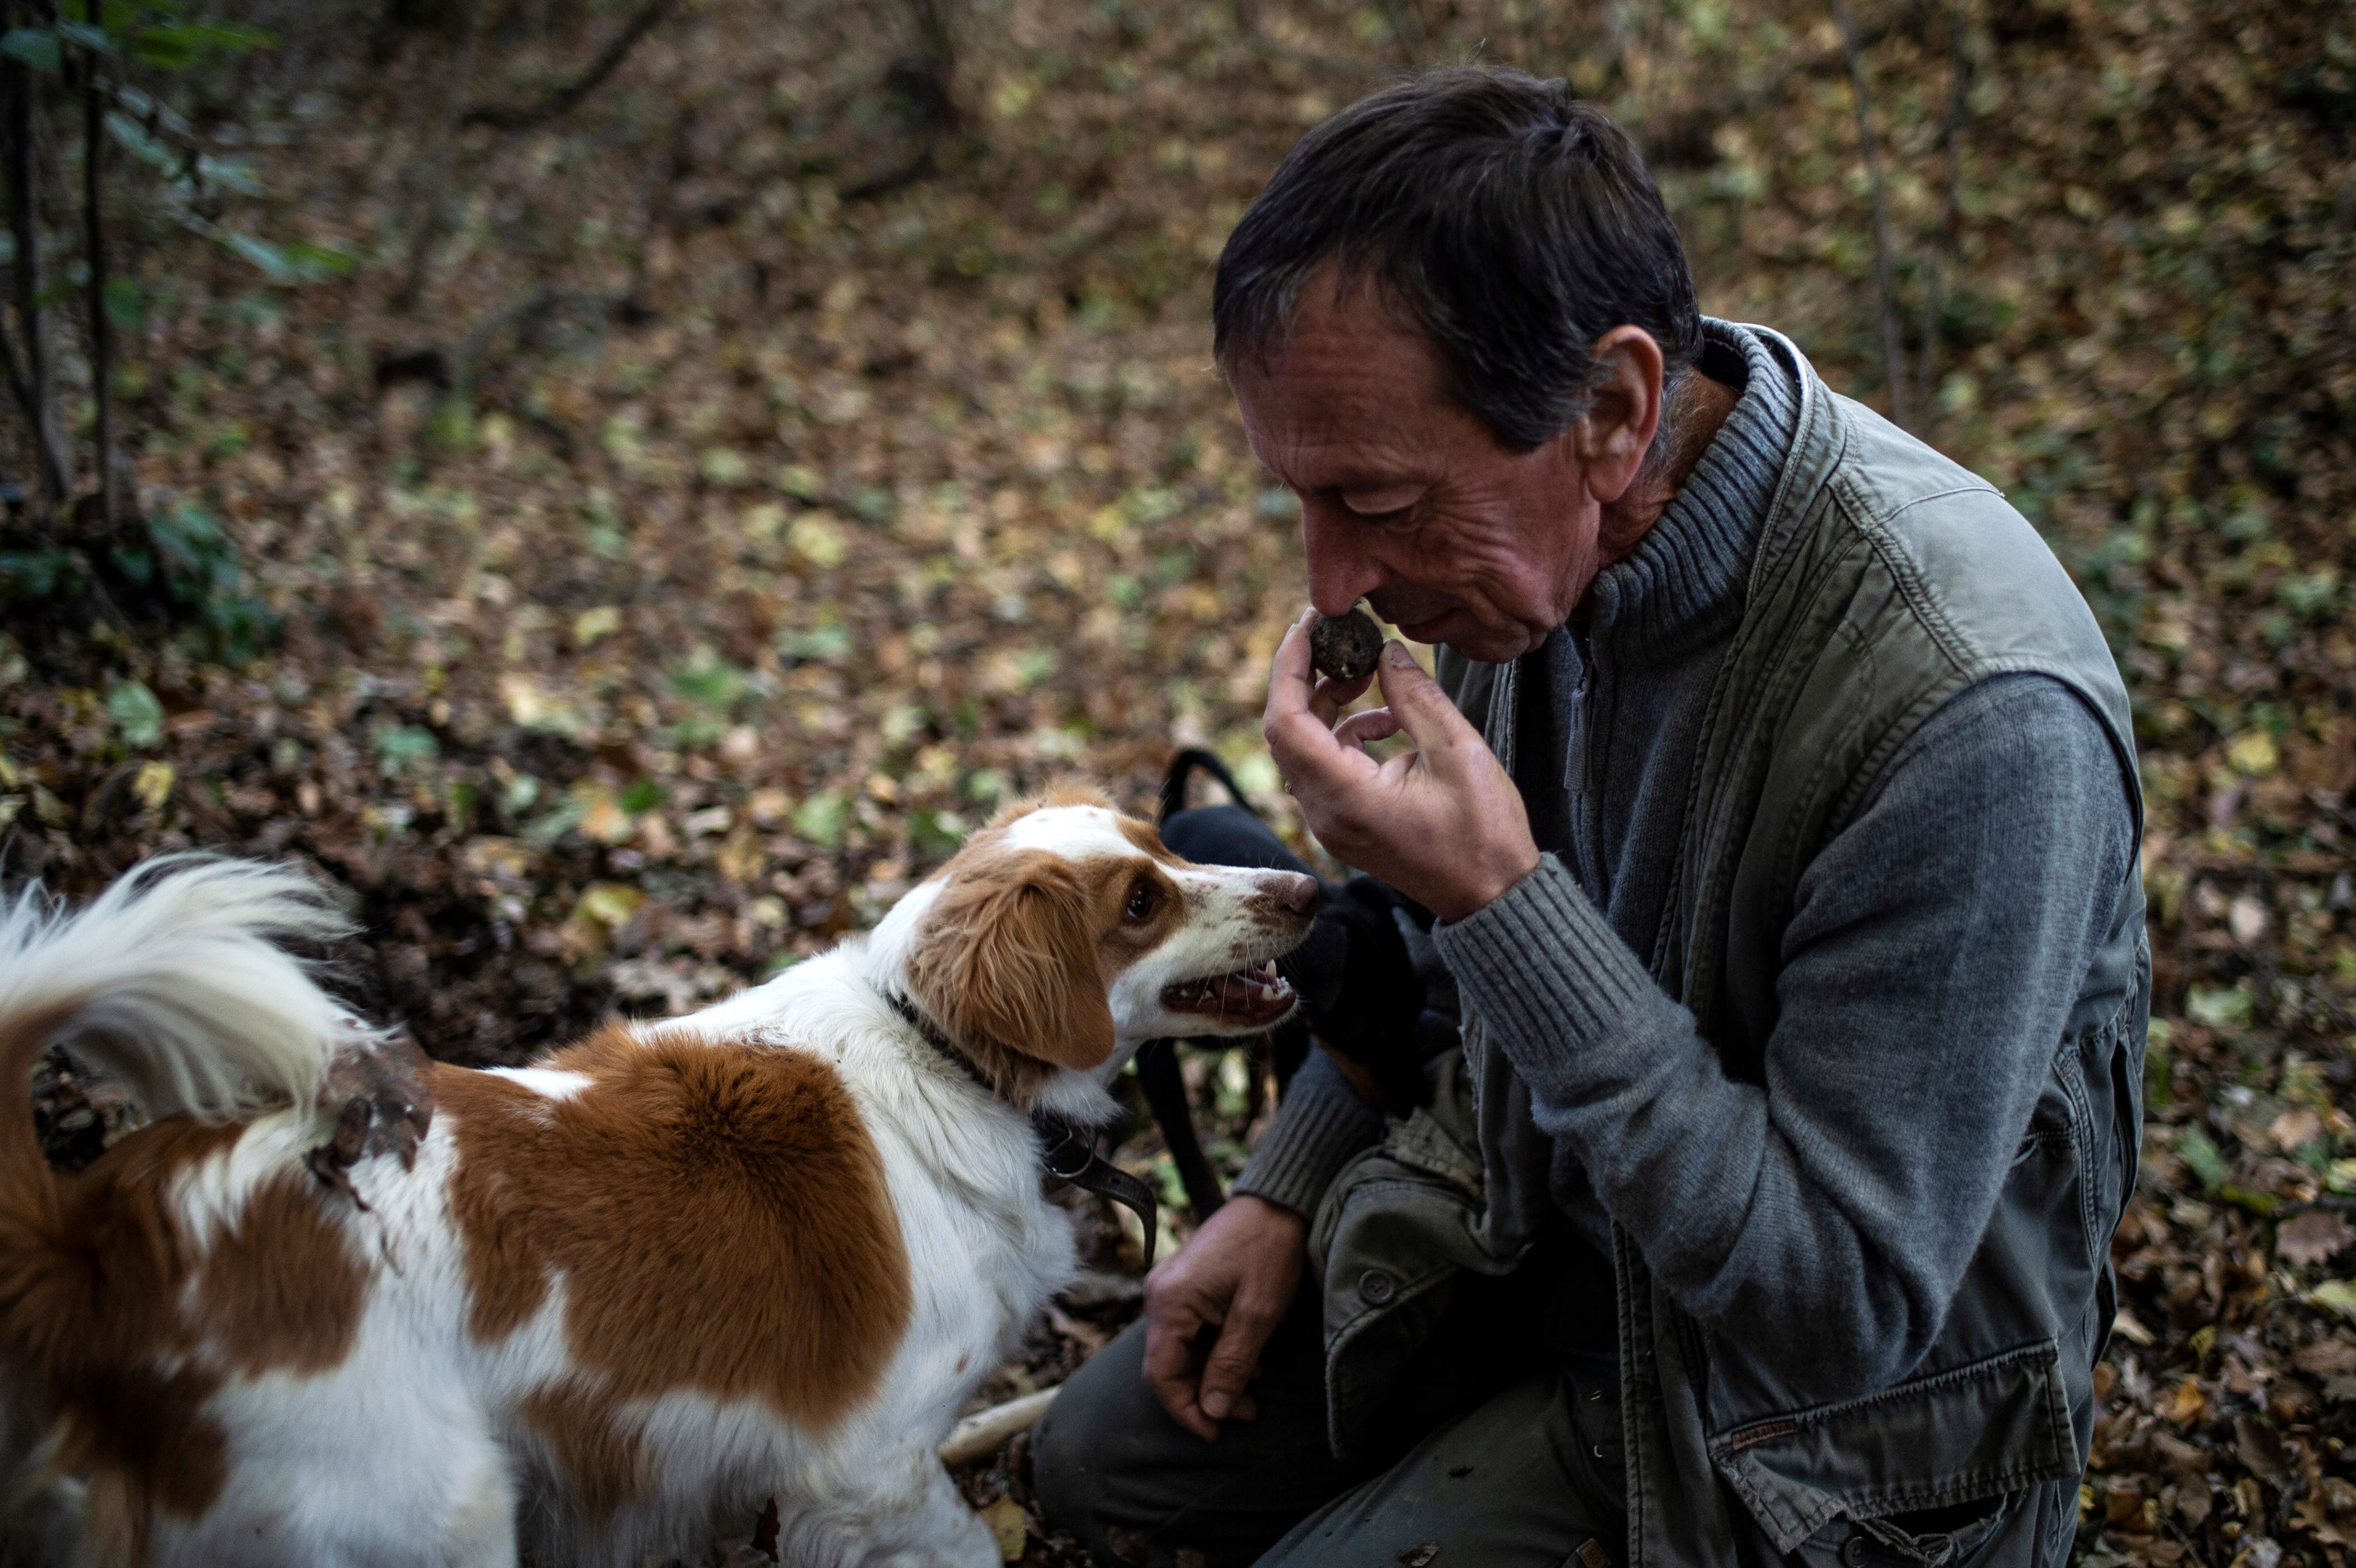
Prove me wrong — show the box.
[1312,322,2148,1564]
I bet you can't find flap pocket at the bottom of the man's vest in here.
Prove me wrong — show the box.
[1710,1340,2081,1561]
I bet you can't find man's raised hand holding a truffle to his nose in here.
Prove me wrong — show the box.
[1263,615,1539,923]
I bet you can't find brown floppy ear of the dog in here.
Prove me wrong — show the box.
[909,850,1112,1071]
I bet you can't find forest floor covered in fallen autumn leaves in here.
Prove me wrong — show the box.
[0,0,2356,1568]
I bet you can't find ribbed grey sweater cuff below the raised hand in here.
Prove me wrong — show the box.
[1433,855,1665,1095]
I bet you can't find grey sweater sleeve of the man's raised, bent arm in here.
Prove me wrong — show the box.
[1439,676,2134,1399]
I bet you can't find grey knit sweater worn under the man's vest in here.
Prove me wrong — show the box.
[1237,322,2132,1387]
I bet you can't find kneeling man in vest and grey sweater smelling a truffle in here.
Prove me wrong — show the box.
[1037,68,2148,1568]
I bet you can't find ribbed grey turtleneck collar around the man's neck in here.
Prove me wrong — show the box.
[1586,318,1800,652]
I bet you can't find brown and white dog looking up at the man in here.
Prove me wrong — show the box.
[0,794,1317,1568]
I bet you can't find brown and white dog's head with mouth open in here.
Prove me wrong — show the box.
[872,791,1317,1104]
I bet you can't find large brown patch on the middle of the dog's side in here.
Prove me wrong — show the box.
[434,1024,909,1450]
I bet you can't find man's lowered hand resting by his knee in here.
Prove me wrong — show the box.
[1145,1193,1308,1443]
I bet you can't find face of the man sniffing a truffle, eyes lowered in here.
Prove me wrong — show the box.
[1232,269,1602,659]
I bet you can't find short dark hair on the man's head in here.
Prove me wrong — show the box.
[1211,66,1701,452]
